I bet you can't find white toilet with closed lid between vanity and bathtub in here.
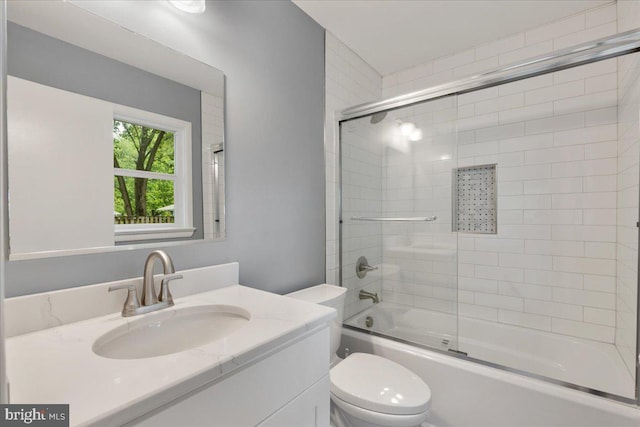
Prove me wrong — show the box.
[287,284,431,427]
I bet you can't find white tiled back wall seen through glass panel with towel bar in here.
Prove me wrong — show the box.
[378,97,458,326]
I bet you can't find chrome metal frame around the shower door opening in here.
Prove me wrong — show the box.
[337,29,640,406]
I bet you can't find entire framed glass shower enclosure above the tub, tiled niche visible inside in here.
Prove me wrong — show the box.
[340,35,640,404]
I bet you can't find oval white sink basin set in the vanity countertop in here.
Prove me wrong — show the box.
[93,305,251,359]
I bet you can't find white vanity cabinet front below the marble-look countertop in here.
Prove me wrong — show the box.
[128,327,329,427]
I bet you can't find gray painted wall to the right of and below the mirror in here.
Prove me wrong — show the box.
[6,1,325,296]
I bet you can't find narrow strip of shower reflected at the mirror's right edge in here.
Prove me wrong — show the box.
[201,92,225,239]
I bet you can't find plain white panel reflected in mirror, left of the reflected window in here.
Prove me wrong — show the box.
[7,76,114,255]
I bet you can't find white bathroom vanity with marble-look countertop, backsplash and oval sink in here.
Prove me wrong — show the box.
[6,264,335,427]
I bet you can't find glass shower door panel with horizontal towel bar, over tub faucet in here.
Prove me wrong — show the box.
[340,96,458,350]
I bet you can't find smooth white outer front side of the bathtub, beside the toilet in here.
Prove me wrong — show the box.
[342,328,640,427]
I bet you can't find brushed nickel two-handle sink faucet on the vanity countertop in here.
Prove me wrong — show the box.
[109,250,182,317]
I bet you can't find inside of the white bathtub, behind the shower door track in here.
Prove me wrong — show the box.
[345,302,640,400]
